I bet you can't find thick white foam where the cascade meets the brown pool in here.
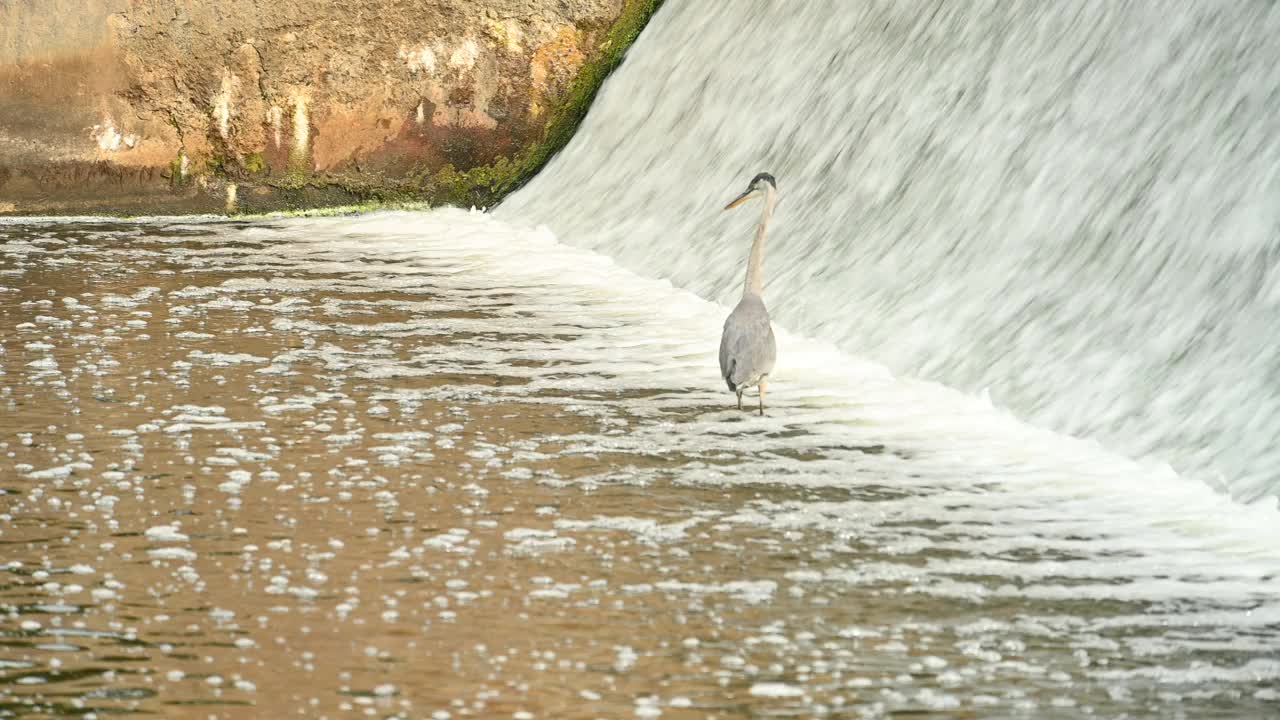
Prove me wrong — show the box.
[40,210,1280,577]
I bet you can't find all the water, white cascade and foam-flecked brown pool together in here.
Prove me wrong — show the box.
[0,0,1280,720]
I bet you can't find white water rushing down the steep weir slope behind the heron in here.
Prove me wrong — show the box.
[497,0,1280,502]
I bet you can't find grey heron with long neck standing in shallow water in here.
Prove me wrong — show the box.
[721,173,778,415]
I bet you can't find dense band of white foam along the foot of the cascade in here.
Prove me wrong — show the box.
[249,210,1280,548]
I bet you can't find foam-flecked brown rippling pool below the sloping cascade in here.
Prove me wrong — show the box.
[0,210,1280,719]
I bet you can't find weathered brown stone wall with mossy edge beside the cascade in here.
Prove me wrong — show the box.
[0,0,660,214]
